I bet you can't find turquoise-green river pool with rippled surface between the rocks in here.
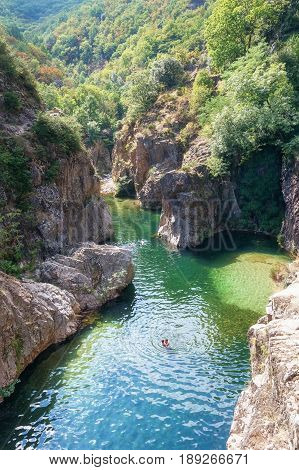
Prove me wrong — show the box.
[0,197,287,450]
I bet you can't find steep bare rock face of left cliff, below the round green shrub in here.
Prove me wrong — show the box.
[32,154,113,256]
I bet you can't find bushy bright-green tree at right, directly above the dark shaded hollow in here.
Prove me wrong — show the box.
[212,44,298,169]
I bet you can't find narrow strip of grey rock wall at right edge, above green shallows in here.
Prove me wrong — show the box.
[282,160,299,253]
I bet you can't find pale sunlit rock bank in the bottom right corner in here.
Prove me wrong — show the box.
[227,278,299,450]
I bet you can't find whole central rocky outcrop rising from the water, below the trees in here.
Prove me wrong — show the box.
[112,92,240,248]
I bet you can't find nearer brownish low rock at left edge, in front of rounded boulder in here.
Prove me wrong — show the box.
[0,272,80,401]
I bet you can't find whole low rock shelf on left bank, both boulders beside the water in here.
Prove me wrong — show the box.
[0,243,134,401]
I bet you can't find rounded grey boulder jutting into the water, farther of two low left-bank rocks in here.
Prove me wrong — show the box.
[39,243,134,311]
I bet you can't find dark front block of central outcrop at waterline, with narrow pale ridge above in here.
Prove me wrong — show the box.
[158,138,240,248]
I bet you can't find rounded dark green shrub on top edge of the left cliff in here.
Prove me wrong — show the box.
[33,113,82,155]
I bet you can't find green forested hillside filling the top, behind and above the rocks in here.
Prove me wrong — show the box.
[1,0,299,274]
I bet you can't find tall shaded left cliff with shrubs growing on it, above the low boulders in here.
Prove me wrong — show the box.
[0,40,113,264]
